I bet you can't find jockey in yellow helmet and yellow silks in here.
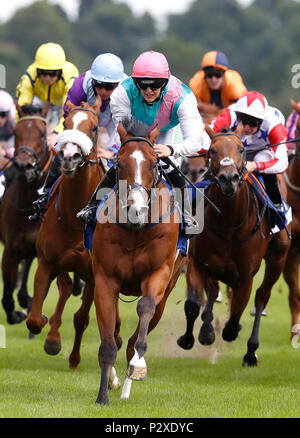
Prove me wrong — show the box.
[16,43,79,148]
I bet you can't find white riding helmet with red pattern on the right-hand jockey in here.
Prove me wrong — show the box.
[233,91,268,120]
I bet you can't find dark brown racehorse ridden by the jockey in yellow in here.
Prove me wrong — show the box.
[0,105,52,324]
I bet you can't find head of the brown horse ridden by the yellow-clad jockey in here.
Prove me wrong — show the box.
[13,104,50,183]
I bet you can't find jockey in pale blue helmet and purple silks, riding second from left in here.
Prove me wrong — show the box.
[30,53,126,220]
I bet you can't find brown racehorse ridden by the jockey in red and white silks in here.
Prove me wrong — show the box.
[177,127,290,366]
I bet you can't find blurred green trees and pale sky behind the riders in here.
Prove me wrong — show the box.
[0,0,300,117]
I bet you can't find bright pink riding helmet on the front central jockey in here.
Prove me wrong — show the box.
[132,51,170,79]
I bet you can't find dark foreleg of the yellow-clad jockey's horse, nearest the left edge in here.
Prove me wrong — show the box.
[2,248,26,324]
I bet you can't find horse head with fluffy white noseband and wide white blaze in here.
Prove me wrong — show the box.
[56,96,102,175]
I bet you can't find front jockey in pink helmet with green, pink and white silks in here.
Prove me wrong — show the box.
[77,51,209,236]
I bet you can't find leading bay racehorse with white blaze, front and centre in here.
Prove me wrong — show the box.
[92,122,185,405]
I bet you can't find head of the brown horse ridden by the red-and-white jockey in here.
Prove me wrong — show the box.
[206,125,246,197]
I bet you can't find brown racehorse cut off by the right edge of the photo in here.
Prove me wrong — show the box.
[283,100,300,337]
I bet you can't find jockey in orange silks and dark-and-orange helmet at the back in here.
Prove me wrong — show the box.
[189,50,247,115]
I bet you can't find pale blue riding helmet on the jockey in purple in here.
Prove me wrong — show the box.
[91,53,124,82]
